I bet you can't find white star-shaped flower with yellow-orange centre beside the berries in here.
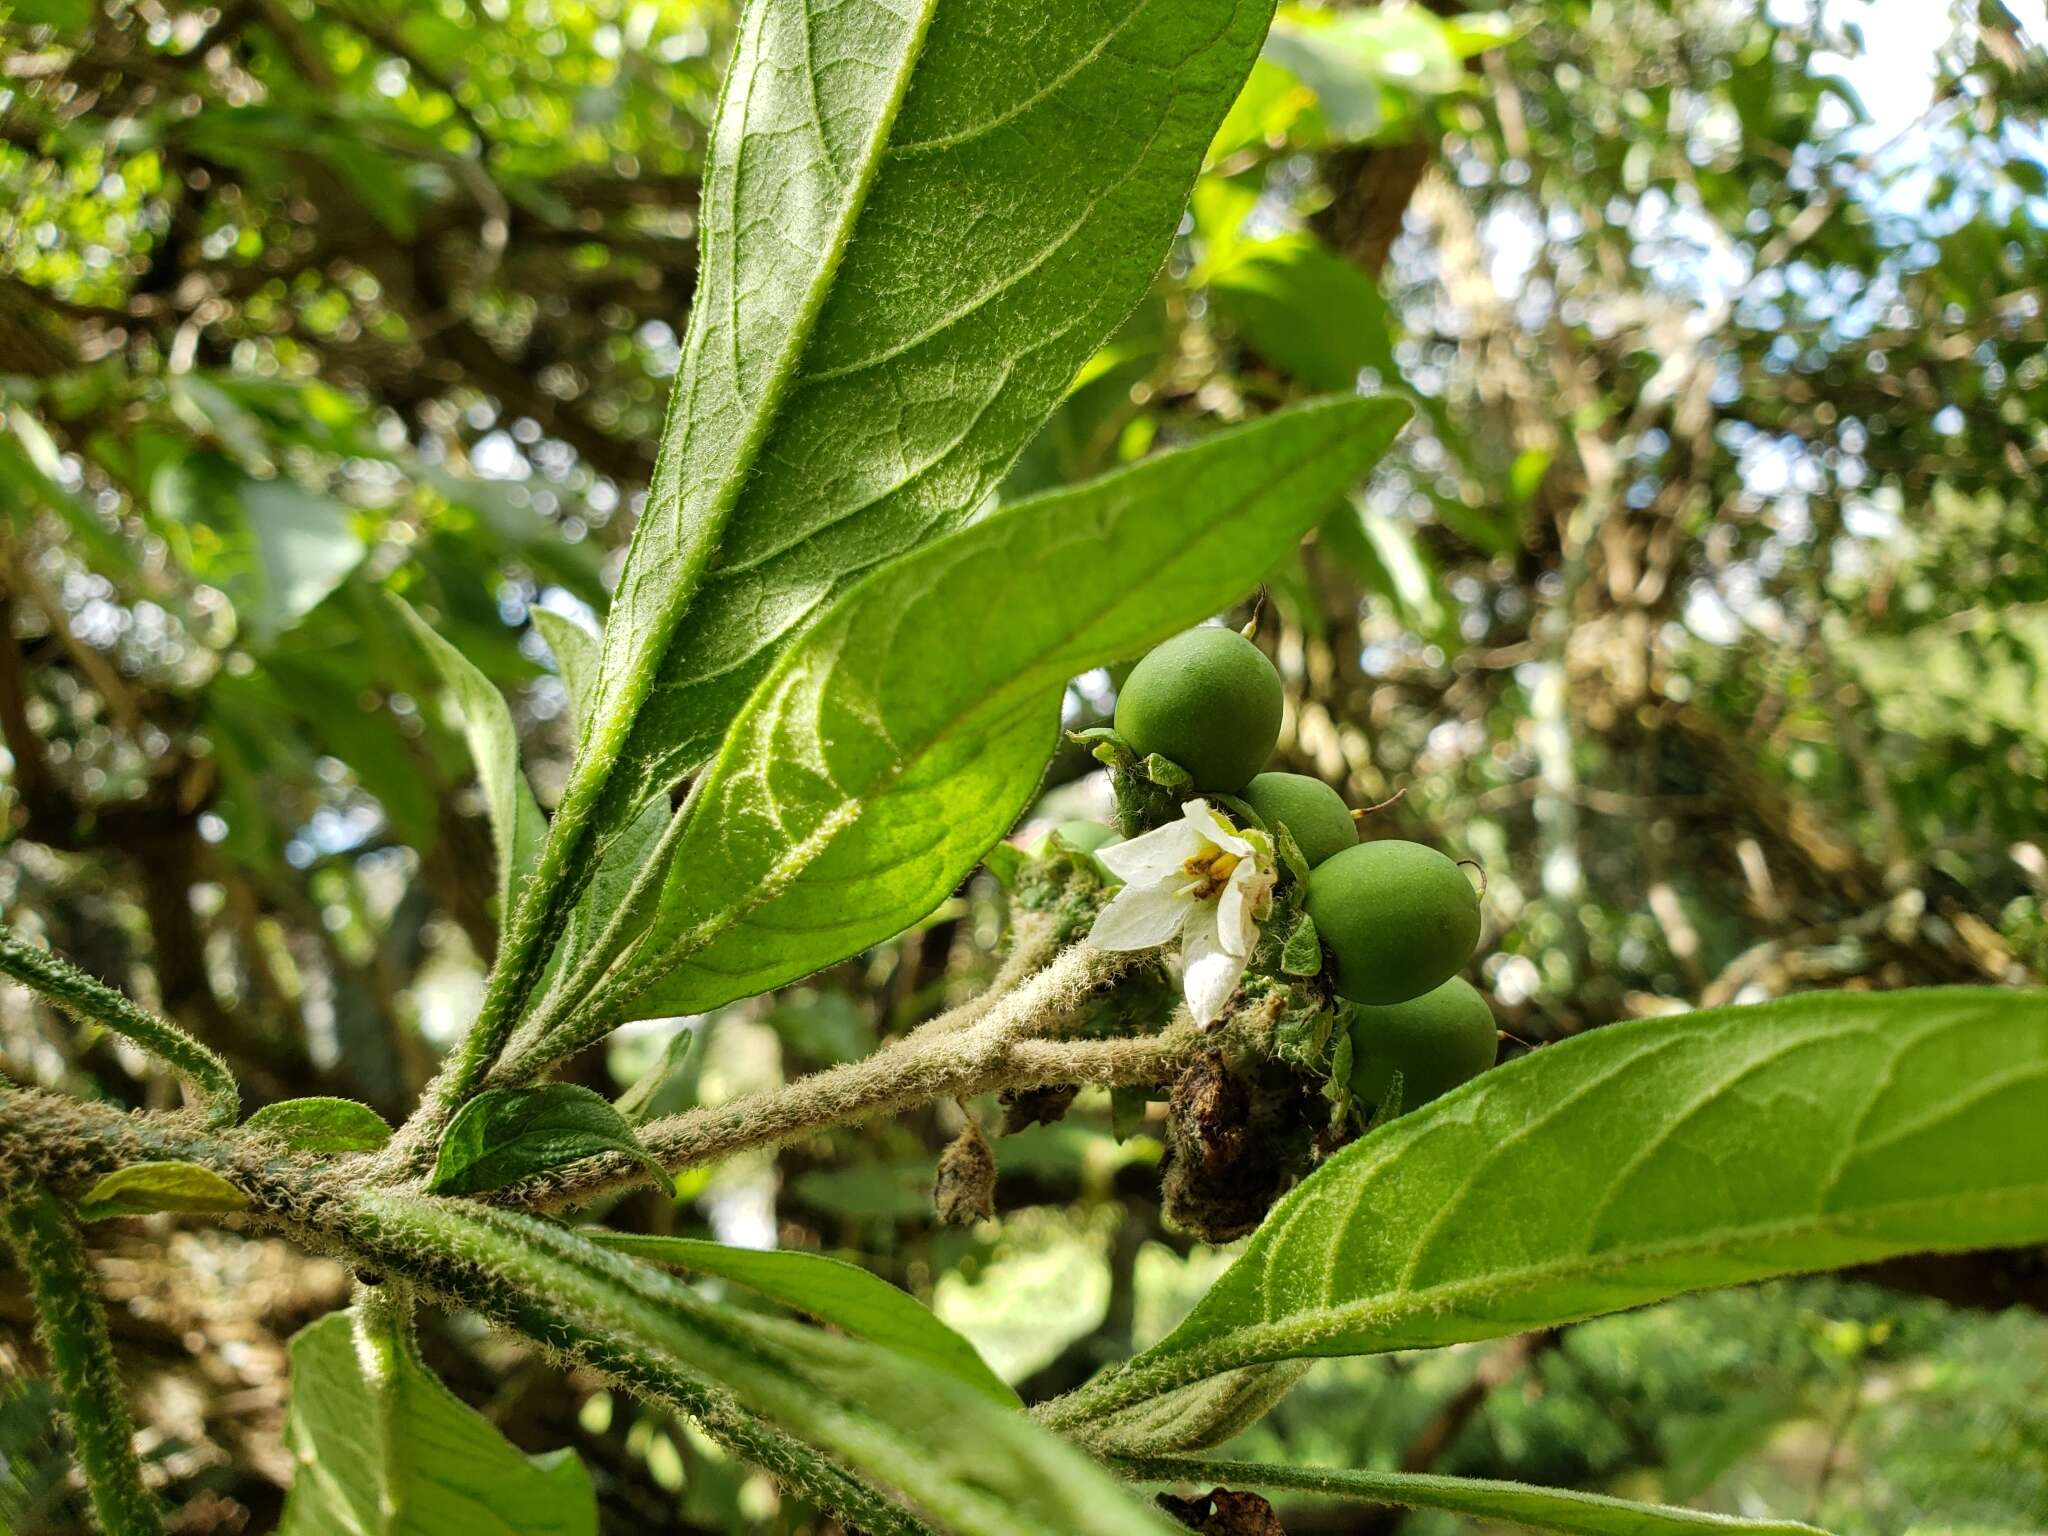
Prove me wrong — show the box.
[1087,801,1274,1030]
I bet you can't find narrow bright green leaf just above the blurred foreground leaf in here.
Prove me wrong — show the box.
[584,1227,1018,1407]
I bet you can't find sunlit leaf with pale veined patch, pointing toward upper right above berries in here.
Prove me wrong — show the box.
[606,397,1407,1028]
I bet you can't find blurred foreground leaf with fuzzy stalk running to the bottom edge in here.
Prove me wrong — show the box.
[356,1194,1184,1536]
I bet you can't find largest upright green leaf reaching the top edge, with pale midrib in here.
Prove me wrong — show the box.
[536,0,1272,1003]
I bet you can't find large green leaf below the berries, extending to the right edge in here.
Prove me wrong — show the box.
[1053,987,2048,1421]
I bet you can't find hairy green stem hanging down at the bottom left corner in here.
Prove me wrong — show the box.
[0,1187,164,1536]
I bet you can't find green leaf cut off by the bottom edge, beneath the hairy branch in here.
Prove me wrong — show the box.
[279,1309,598,1536]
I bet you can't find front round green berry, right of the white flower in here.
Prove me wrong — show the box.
[1307,838,1479,1006]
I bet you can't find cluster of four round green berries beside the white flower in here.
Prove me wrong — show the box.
[1114,627,1497,1108]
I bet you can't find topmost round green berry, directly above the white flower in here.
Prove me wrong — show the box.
[1116,625,1280,795]
